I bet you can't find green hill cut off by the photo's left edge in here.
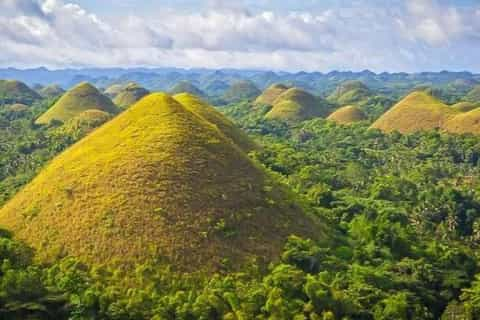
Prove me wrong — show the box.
[0,80,42,105]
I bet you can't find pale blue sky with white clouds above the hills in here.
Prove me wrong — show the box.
[0,0,480,72]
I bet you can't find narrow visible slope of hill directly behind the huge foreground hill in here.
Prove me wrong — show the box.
[173,93,256,151]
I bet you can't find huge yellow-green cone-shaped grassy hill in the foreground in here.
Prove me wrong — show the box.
[0,94,322,273]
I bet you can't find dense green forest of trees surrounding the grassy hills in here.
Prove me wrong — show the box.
[0,76,480,320]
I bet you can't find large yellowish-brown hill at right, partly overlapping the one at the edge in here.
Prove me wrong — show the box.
[372,91,459,133]
